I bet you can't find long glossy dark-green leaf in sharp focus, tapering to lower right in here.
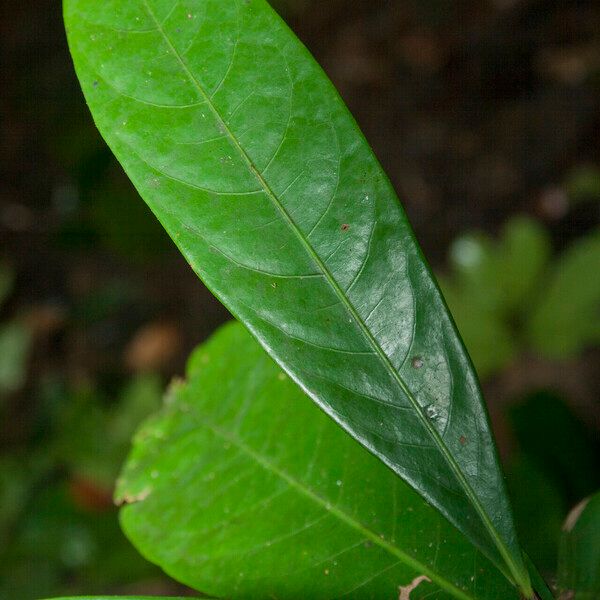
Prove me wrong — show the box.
[64,0,530,595]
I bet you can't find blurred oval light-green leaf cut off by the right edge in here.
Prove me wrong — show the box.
[528,230,600,358]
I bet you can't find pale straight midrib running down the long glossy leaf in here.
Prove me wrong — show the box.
[142,0,522,581]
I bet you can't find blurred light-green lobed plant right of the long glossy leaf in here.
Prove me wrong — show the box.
[441,217,600,377]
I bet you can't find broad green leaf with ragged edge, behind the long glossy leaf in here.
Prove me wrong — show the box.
[116,323,518,600]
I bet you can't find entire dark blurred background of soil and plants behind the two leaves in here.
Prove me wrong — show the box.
[0,0,600,600]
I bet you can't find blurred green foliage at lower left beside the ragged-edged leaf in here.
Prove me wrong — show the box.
[0,375,162,600]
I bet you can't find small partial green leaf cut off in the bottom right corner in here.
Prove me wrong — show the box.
[558,493,600,600]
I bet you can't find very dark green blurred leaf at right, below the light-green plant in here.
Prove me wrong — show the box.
[507,391,600,574]
